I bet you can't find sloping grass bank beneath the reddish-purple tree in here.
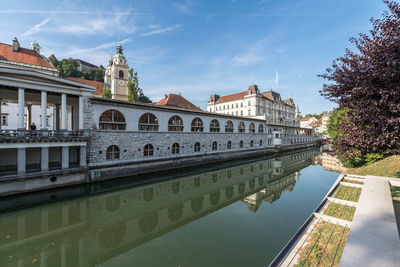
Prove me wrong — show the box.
[347,155,400,178]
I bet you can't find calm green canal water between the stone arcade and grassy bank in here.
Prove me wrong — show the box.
[0,150,338,267]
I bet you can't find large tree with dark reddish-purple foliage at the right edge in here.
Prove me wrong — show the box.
[319,0,400,162]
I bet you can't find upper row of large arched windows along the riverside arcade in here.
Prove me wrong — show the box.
[99,109,264,133]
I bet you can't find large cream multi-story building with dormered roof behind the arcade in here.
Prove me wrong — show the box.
[207,85,300,127]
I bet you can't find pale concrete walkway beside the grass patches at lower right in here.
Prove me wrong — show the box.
[340,176,400,267]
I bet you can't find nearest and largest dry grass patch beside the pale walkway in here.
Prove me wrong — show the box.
[295,222,350,266]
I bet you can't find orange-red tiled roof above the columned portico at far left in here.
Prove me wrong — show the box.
[0,44,55,69]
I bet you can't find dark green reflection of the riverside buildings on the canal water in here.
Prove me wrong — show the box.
[0,151,314,266]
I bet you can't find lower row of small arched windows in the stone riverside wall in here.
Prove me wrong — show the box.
[106,139,263,160]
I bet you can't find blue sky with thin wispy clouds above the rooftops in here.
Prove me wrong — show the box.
[0,0,385,114]
